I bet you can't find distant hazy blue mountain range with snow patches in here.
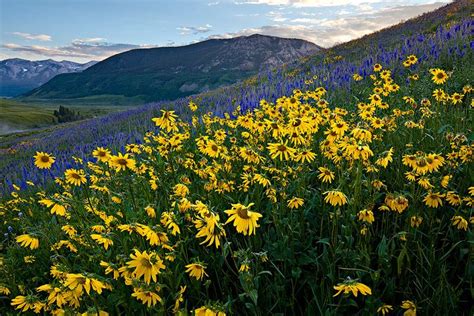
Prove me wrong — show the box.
[0,58,96,97]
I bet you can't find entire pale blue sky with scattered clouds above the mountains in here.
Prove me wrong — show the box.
[0,0,451,62]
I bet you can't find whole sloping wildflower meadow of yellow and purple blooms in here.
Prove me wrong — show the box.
[0,2,474,316]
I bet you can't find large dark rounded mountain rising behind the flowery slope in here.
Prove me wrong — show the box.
[21,34,321,101]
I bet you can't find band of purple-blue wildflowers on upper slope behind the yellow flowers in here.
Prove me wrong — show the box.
[0,1,474,192]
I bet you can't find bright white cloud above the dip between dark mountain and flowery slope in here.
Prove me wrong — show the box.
[209,0,445,47]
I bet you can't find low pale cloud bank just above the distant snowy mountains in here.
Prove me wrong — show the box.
[1,38,156,61]
